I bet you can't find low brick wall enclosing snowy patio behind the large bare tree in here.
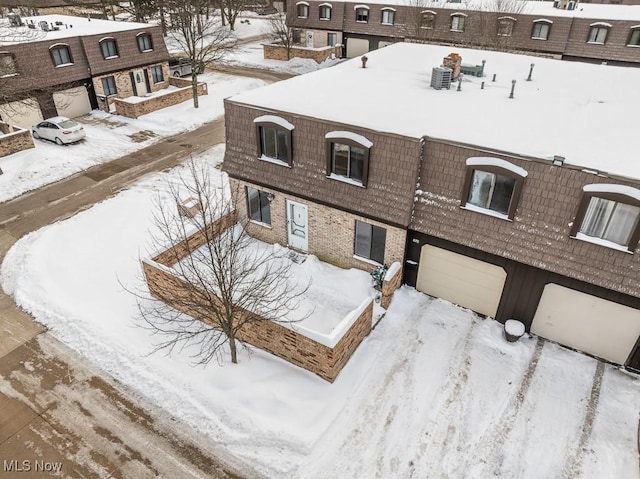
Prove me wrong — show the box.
[142,215,373,382]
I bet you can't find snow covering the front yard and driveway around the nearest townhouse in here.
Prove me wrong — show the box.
[0,146,640,479]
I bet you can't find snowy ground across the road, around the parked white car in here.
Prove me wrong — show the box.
[0,73,265,203]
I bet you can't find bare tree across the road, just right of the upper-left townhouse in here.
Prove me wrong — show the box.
[164,0,233,108]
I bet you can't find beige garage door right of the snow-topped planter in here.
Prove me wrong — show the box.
[531,284,640,364]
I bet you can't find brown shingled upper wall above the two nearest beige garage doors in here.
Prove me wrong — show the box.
[410,140,640,296]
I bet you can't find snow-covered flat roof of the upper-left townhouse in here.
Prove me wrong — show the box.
[0,15,153,45]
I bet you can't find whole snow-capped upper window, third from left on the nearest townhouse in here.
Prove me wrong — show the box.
[461,158,527,219]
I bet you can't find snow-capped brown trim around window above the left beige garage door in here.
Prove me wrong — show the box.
[460,157,529,221]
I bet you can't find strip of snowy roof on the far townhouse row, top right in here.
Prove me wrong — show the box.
[349,0,640,20]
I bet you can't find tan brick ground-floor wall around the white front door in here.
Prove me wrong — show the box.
[230,179,407,271]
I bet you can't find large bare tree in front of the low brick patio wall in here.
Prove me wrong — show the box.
[138,160,310,364]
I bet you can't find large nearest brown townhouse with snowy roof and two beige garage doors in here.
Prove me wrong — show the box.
[223,43,640,370]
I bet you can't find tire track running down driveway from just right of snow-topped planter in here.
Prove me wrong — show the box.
[467,338,545,476]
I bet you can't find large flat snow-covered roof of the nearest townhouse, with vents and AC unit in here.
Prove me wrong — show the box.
[232,43,640,179]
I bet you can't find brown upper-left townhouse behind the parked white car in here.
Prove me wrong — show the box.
[0,15,169,128]
